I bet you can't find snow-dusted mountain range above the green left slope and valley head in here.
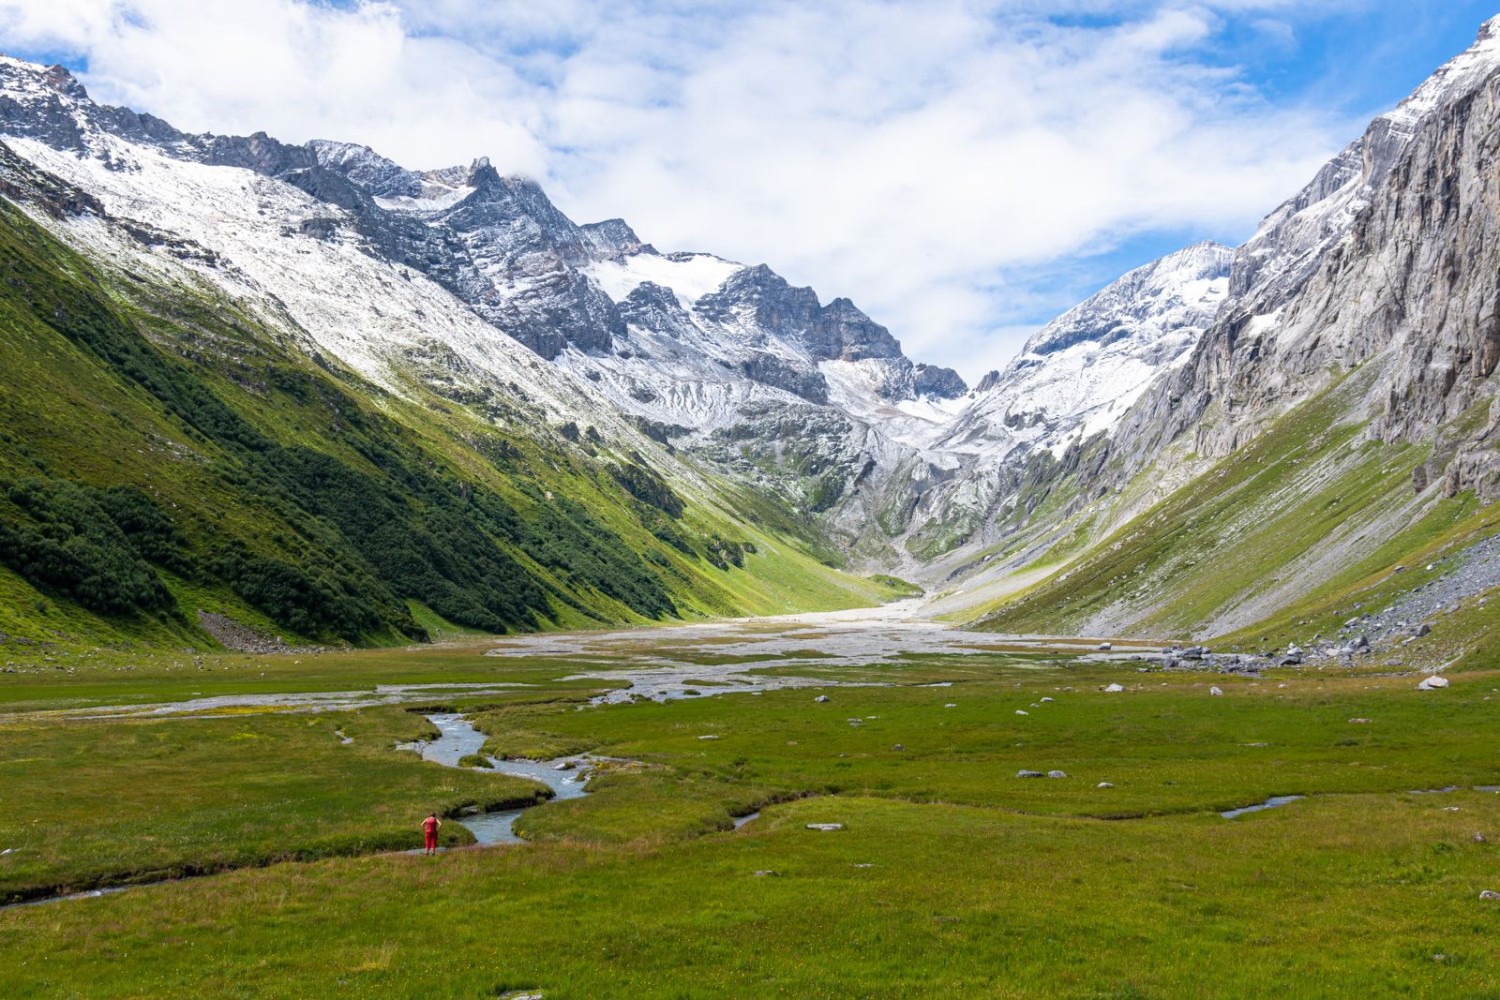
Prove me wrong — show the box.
[0,58,1248,576]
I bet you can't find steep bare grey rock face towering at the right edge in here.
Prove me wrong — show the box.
[1116,22,1500,499]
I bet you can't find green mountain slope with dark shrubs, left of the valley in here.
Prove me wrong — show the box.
[0,181,885,646]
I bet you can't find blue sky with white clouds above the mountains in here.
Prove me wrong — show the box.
[0,0,1500,381]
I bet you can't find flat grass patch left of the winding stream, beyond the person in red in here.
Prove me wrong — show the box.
[0,709,555,901]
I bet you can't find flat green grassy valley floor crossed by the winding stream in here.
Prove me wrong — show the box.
[0,619,1500,1000]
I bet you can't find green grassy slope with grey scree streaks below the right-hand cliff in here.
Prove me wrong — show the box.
[981,364,1500,649]
